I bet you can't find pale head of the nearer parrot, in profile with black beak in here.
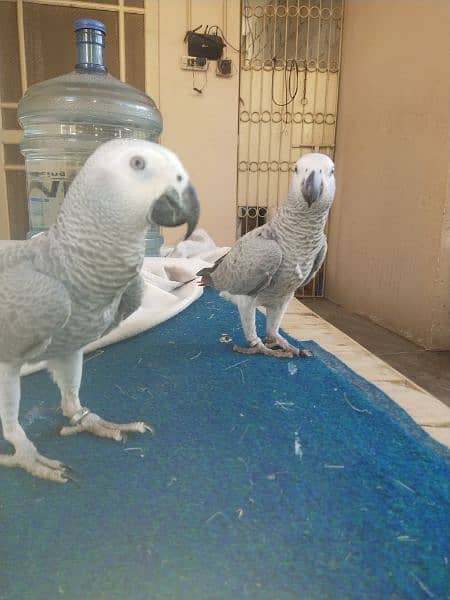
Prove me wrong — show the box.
[86,140,200,238]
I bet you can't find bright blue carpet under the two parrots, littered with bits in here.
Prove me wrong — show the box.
[0,291,450,600]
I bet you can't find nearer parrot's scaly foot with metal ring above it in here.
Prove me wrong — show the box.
[60,407,154,442]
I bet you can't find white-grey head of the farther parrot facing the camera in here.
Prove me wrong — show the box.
[291,152,336,210]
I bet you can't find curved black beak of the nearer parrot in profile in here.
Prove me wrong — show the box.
[150,185,200,240]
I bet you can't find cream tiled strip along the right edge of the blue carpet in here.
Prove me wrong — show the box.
[282,299,450,446]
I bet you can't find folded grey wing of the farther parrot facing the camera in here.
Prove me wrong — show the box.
[197,225,283,296]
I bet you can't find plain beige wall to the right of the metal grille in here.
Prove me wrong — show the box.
[326,0,449,349]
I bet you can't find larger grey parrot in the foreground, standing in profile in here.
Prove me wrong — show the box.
[0,140,199,482]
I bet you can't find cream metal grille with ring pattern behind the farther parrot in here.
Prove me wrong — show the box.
[237,0,344,296]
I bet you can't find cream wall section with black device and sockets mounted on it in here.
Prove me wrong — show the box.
[155,0,240,245]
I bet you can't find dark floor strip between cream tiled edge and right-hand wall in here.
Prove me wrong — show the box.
[301,298,450,406]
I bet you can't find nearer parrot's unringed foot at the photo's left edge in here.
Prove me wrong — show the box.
[0,440,73,483]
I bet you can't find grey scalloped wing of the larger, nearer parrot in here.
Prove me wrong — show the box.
[0,256,71,362]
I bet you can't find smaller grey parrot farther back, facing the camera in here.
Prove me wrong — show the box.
[197,153,336,357]
